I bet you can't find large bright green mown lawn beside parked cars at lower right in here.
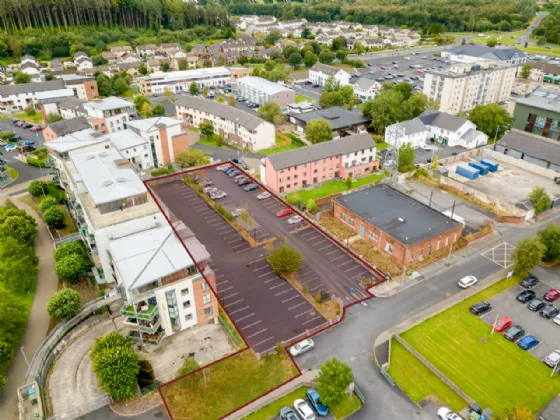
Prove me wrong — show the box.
[401,277,560,416]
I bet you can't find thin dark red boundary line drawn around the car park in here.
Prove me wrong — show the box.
[143,161,387,420]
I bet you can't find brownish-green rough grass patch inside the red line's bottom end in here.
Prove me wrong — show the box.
[160,350,298,420]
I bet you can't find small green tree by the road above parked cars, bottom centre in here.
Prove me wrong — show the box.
[317,358,354,407]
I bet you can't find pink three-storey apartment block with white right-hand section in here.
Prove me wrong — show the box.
[260,133,379,194]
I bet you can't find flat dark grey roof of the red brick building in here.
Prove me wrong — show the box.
[336,184,459,246]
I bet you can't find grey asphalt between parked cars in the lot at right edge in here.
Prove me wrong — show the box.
[481,281,560,360]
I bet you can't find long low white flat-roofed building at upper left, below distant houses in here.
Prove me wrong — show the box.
[140,67,231,96]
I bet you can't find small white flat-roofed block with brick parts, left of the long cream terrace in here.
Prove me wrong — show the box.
[83,96,136,133]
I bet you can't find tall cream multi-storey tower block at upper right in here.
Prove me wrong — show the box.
[423,62,517,114]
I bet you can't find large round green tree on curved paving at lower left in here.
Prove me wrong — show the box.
[91,332,140,401]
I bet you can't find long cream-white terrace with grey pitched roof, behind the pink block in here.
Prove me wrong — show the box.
[175,95,276,151]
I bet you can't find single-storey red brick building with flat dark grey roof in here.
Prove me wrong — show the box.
[333,184,463,266]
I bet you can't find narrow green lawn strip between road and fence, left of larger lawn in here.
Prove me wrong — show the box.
[388,339,467,413]
